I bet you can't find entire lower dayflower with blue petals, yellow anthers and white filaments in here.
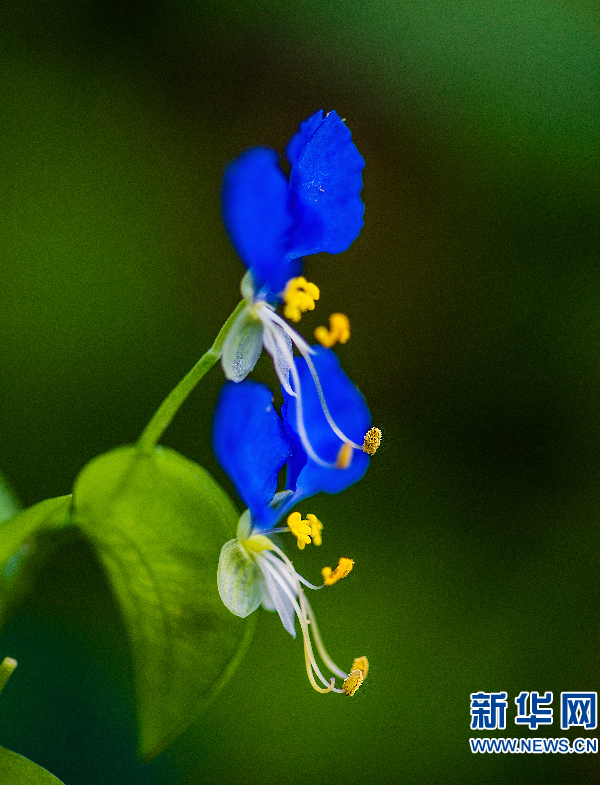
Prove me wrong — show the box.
[213,370,378,695]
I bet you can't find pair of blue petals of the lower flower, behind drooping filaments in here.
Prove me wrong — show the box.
[213,347,371,530]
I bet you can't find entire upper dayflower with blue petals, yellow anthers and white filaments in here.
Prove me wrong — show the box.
[221,110,364,466]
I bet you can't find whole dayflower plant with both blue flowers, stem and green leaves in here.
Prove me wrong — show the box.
[0,111,381,760]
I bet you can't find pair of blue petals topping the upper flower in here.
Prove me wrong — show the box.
[222,109,365,301]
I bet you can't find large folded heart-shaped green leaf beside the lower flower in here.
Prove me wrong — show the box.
[73,447,253,760]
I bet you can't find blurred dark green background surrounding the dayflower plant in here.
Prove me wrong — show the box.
[0,0,600,785]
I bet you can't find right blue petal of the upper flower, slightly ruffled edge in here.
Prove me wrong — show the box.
[287,112,365,257]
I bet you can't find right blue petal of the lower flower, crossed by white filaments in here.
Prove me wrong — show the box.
[281,347,371,500]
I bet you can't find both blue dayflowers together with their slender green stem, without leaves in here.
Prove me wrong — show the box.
[129,111,381,712]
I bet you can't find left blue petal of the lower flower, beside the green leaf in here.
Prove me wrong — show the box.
[212,381,294,528]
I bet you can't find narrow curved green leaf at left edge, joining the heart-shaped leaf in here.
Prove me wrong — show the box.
[0,496,71,624]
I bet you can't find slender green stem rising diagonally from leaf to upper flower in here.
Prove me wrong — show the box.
[137,300,247,454]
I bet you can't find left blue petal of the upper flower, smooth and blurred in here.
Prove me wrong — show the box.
[221,147,297,292]
